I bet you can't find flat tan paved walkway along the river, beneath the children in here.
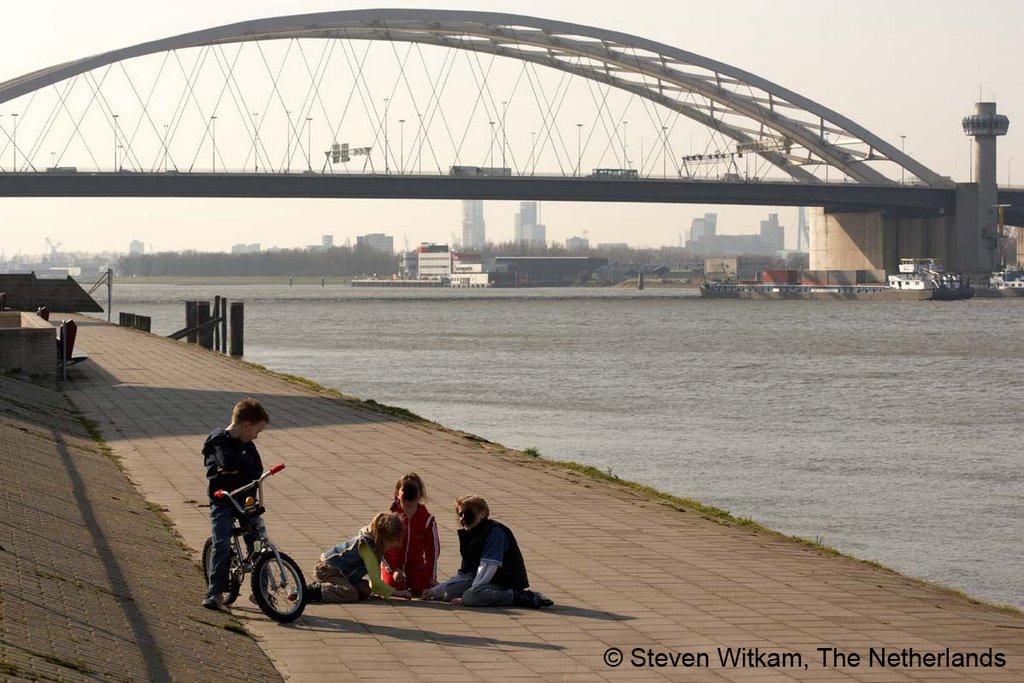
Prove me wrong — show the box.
[67,323,1024,681]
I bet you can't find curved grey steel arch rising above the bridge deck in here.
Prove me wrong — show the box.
[0,9,953,194]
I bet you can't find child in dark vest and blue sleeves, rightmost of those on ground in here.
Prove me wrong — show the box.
[423,496,554,609]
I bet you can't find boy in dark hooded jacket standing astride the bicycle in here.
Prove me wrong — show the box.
[203,398,270,609]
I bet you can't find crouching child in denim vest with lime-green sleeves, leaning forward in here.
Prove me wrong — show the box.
[306,512,412,602]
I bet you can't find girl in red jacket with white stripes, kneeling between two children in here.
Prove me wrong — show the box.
[381,472,441,597]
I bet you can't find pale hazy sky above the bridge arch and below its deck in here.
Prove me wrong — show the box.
[0,0,1024,256]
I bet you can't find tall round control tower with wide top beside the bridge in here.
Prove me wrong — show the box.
[963,102,1010,270]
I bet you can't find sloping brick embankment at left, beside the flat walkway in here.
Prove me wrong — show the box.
[0,376,281,681]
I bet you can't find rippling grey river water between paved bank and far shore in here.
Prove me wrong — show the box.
[108,285,1024,606]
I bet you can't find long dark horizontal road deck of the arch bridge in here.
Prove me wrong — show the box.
[0,172,970,215]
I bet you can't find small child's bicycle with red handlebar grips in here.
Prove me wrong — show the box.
[203,465,309,623]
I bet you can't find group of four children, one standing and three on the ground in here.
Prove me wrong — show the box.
[203,398,553,609]
